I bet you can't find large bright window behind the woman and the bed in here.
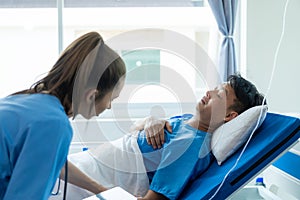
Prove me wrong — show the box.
[0,0,219,152]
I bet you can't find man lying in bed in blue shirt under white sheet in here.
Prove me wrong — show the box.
[51,75,263,200]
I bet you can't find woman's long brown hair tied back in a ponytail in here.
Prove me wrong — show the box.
[12,32,126,115]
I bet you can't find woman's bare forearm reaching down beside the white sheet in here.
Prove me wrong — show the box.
[60,161,107,194]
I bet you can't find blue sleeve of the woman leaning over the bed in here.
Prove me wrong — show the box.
[4,119,72,200]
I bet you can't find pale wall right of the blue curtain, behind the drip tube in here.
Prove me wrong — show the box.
[246,0,300,113]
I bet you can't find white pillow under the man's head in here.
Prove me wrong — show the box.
[211,105,268,165]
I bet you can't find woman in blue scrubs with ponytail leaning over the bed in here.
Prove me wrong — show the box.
[0,32,126,199]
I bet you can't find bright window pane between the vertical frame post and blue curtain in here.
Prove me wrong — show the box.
[64,6,219,103]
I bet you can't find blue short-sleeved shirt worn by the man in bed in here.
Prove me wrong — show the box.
[137,114,212,199]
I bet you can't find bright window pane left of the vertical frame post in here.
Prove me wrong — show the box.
[0,8,58,97]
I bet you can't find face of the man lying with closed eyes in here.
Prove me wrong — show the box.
[197,82,236,129]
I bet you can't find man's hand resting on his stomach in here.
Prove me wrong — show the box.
[144,117,172,149]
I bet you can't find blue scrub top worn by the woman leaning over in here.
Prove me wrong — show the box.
[0,94,73,200]
